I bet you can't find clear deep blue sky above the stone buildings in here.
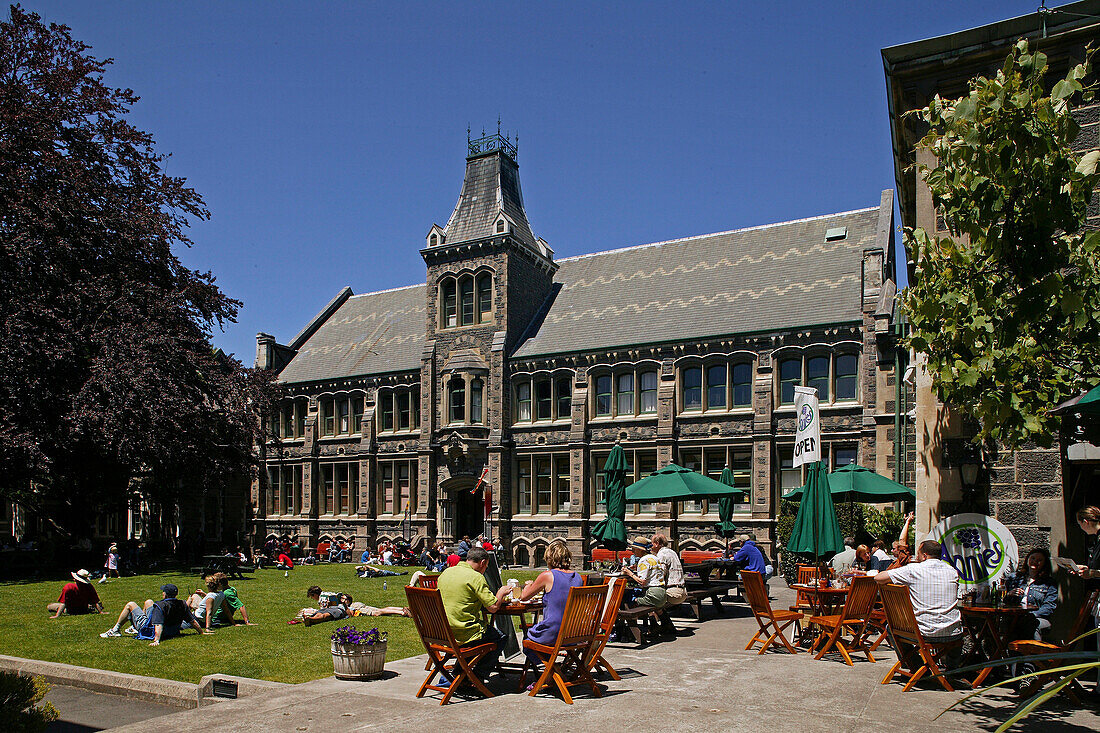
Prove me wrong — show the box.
[24,0,1051,364]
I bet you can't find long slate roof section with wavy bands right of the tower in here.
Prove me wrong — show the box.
[514,206,889,358]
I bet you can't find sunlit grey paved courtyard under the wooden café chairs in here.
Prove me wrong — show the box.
[101,588,1100,733]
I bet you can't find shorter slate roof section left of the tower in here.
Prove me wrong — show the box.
[279,285,428,382]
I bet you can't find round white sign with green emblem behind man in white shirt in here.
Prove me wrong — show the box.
[925,514,1020,586]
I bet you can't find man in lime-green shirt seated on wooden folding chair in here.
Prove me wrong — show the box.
[438,547,512,679]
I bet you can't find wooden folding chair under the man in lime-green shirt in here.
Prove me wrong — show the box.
[405,586,495,705]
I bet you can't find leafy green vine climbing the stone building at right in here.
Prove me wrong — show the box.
[903,41,1100,446]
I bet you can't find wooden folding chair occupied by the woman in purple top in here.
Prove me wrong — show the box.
[519,586,607,704]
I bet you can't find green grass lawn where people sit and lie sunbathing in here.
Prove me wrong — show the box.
[0,564,536,682]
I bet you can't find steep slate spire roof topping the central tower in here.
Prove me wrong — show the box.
[443,152,537,248]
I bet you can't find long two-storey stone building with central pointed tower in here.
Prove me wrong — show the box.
[254,134,913,565]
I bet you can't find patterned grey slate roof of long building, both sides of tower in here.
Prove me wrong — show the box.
[279,197,893,382]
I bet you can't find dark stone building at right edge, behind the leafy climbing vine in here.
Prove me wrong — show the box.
[882,0,1100,557]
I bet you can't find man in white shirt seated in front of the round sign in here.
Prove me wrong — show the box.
[875,539,963,643]
